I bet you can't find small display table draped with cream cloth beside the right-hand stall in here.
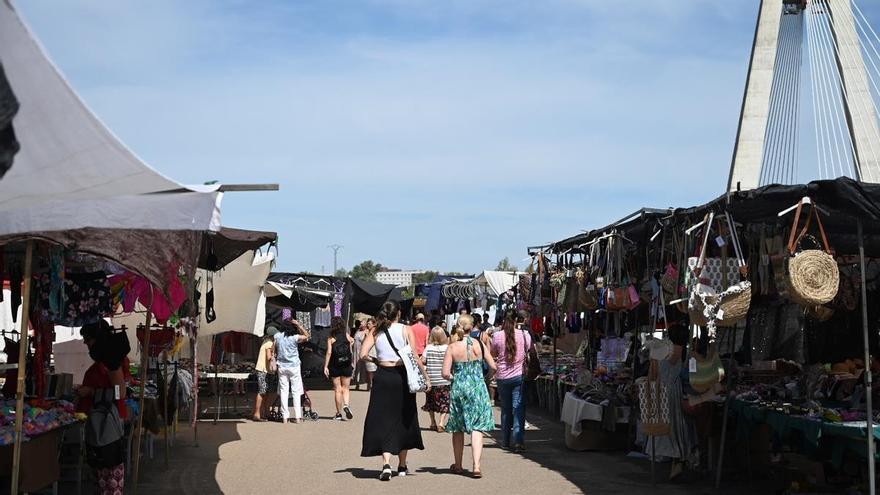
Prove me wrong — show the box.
[561,392,631,450]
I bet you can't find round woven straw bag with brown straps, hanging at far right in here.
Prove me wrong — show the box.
[786,200,840,307]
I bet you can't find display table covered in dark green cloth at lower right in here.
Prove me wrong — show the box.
[730,400,880,467]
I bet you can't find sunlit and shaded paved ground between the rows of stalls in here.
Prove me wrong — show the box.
[118,384,764,495]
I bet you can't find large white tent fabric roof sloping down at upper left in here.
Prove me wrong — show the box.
[0,0,222,236]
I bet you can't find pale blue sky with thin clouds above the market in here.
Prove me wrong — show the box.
[18,0,872,272]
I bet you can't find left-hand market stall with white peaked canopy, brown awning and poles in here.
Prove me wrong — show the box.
[0,2,278,493]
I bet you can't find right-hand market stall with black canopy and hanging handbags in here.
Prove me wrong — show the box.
[523,178,880,488]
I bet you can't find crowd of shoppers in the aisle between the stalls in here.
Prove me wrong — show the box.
[244,302,532,481]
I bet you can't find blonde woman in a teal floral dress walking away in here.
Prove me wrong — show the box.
[443,315,495,478]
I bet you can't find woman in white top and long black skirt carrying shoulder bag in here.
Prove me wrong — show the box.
[359,301,431,481]
